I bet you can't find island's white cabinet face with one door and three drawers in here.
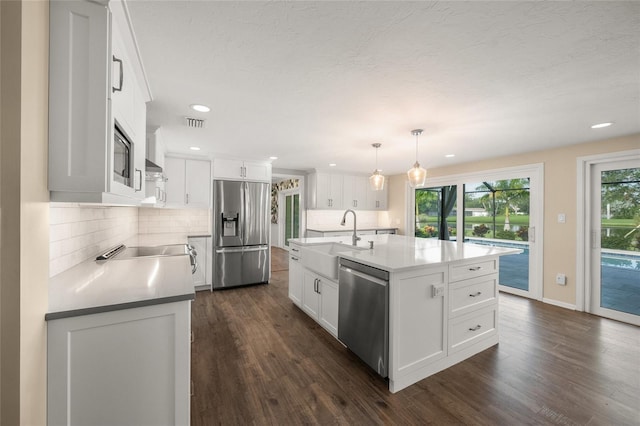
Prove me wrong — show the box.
[389,257,499,392]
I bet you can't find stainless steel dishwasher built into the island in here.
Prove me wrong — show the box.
[338,259,389,377]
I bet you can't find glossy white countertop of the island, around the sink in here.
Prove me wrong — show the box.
[289,235,522,272]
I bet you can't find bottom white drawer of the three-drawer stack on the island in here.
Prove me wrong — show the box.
[449,309,498,354]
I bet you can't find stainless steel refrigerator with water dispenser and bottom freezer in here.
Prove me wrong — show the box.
[212,180,271,290]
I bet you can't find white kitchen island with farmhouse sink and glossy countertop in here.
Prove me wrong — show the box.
[289,235,520,392]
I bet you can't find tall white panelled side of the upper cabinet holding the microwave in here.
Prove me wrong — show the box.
[49,1,113,194]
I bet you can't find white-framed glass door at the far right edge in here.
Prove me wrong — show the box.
[585,159,640,325]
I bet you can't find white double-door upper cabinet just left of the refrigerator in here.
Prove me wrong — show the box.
[164,157,211,209]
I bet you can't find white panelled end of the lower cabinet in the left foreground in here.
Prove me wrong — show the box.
[47,300,191,426]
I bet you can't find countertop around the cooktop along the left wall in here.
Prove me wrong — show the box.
[45,234,200,320]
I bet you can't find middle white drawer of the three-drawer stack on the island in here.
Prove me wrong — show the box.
[449,274,498,316]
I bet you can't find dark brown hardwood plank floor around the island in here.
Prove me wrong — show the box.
[191,248,640,426]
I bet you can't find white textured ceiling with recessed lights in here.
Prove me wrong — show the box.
[128,0,640,174]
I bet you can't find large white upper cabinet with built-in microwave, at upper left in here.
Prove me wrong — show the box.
[49,1,151,204]
